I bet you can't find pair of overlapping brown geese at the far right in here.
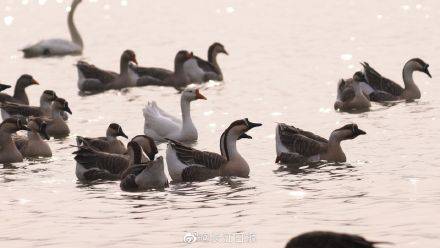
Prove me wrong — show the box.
[334,58,431,111]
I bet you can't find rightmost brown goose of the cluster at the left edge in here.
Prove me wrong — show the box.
[42,97,72,139]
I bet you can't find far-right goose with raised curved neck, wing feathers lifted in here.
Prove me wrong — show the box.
[361,58,431,102]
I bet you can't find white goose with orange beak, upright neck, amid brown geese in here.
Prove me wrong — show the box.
[143,89,206,142]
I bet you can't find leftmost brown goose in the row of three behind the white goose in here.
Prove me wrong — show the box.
[76,50,137,92]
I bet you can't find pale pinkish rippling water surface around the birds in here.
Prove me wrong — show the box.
[0,0,440,248]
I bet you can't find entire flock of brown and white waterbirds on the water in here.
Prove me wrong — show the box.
[0,0,431,248]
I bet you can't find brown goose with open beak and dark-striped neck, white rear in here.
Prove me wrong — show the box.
[166,118,262,182]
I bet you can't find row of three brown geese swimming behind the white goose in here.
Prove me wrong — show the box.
[76,42,228,93]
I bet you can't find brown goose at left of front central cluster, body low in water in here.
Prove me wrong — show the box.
[73,141,153,181]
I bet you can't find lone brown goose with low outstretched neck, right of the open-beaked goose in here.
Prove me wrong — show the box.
[275,123,366,163]
